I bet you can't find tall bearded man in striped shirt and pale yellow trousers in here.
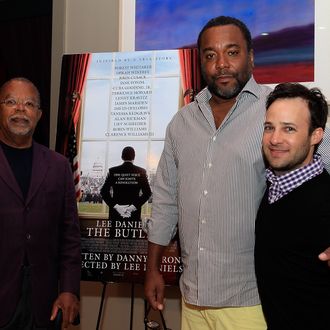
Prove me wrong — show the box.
[145,16,330,330]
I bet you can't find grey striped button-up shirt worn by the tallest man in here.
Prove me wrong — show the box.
[148,77,330,307]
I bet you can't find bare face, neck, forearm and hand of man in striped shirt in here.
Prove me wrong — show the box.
[144,25,253,310]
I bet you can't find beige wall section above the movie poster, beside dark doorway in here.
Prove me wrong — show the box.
[50,0,119,148]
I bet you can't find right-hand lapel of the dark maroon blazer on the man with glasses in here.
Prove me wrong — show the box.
[26,142,49,204]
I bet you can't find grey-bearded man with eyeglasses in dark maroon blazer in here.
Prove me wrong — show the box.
[0,78,81,330]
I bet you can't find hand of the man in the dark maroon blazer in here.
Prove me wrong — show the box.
[50,292,80,329]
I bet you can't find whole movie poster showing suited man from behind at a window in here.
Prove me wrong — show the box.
[57,50,189,284]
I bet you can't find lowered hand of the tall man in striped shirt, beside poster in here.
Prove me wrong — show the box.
[144,270,165,311]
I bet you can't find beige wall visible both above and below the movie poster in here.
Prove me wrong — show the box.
[50,0,180,330]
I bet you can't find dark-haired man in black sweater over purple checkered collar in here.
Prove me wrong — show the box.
[255,83,330,330]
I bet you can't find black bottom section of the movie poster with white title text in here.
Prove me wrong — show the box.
[81,219,182,285]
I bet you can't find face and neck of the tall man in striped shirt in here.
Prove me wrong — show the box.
[200,25,254,128]
